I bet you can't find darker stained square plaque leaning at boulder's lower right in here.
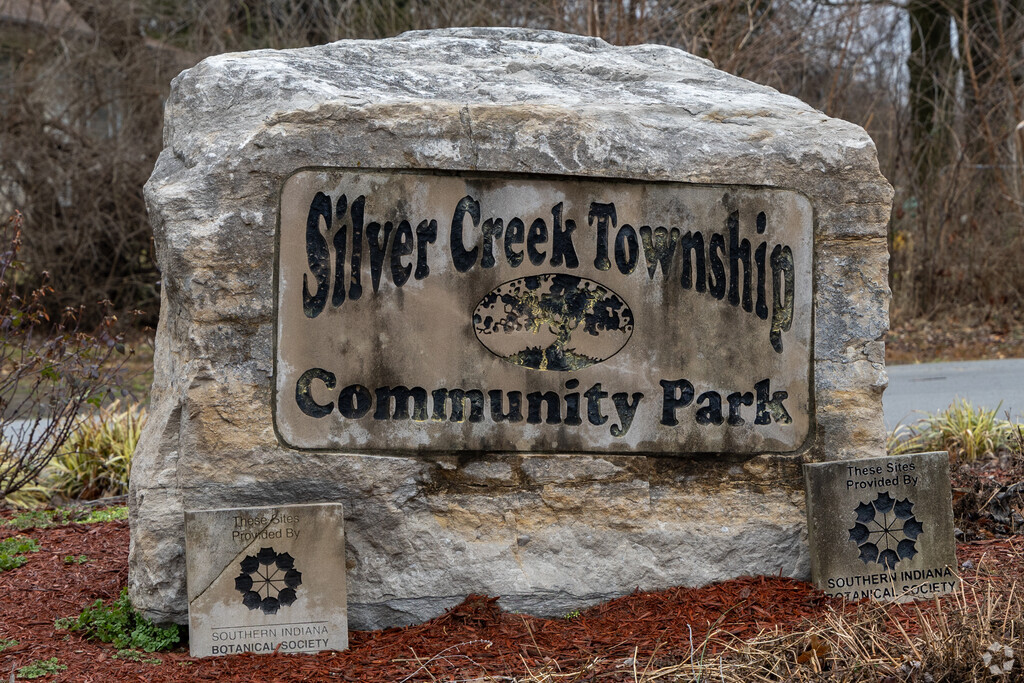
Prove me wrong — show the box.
[804,453,958,601]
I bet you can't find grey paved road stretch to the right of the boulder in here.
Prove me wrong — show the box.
[882,358,1024,429]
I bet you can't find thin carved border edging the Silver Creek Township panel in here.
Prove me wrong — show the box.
[270,166,818,462]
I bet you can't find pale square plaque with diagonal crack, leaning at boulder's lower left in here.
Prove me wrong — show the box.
[185,504,348,656]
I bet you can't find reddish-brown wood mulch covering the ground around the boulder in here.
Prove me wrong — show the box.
[0,522,1024,683]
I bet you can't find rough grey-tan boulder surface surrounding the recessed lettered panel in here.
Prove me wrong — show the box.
[129,29,892,629]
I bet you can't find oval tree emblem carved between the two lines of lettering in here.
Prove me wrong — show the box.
[473,273,633,372]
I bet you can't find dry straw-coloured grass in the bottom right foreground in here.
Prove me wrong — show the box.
[516,583,1024,683]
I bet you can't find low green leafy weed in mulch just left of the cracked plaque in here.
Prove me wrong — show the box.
[54,589,181,652]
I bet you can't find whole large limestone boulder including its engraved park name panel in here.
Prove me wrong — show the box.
[129,29,892,629]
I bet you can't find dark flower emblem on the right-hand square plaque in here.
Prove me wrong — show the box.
[850,492,924,569]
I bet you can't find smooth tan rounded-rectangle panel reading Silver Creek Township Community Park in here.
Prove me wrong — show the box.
[274,169,813,455]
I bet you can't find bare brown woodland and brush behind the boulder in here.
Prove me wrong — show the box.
[0,0,1024,325]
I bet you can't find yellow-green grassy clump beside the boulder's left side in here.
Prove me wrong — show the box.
[42,401,145,501]
